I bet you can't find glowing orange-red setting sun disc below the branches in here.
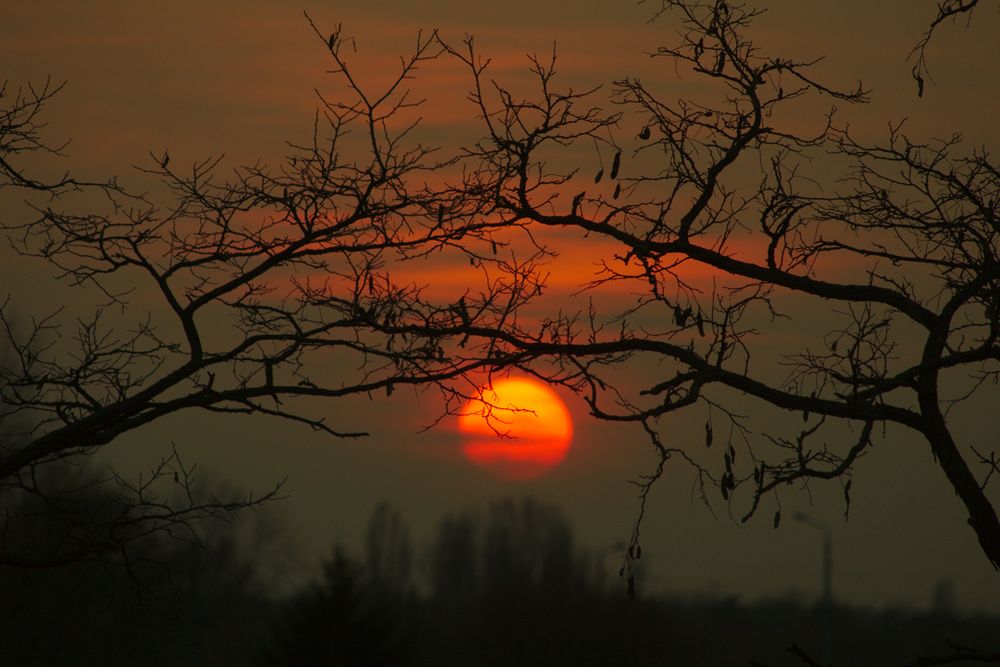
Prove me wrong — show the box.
[458,377,573,480]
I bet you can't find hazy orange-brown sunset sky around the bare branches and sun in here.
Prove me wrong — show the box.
[0,0,1000,610]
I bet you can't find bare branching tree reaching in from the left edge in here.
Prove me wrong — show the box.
[0,21,534,560]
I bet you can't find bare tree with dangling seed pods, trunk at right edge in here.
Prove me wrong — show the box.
[391,0,1000,580]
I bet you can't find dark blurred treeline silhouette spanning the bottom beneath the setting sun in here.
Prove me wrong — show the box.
[0,486,1000,666]
